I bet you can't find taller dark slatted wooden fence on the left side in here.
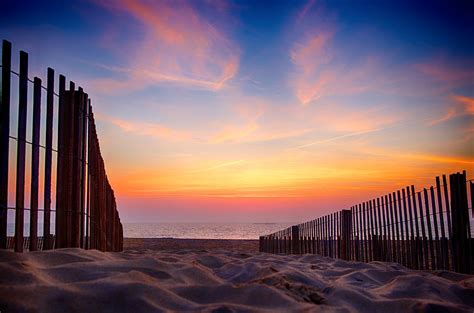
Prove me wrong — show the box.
[0,41,123,252]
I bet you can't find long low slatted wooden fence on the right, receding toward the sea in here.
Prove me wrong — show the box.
[260,171,474,273]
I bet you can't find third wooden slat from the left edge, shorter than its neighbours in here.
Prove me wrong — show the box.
[29,77,41,251]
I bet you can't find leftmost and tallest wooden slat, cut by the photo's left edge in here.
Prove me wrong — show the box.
[0,40,12,249]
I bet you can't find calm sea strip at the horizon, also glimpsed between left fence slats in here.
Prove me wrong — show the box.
[7,223,295,239]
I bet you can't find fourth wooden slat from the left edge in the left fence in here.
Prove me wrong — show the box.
[43,68,54,250]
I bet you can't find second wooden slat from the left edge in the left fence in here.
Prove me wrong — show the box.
[15,51,28,252]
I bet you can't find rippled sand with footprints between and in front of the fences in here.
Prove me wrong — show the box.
[0,239,474,313]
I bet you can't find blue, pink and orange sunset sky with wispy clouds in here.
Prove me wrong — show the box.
[0,0,474,222]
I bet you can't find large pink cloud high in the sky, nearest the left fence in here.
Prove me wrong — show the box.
[93,0,240,92]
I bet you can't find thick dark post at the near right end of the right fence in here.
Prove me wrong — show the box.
[449,173,472,274]
